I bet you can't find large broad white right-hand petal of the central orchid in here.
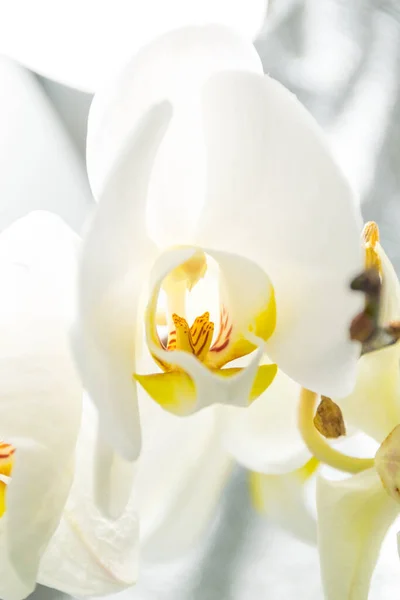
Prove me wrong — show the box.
[195,73,362,396]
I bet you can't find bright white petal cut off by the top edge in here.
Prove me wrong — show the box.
[0,0,267,92]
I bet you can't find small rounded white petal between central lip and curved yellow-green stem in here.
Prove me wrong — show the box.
[223,371,310,474]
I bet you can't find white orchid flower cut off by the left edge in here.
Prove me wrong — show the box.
[0,213,138,600]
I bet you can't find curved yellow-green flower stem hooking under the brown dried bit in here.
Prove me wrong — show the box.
[299,388,374,473]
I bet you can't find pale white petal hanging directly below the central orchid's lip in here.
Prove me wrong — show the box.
[133,398,232,561]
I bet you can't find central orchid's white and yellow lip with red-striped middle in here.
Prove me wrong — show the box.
[134,246,277,415]
